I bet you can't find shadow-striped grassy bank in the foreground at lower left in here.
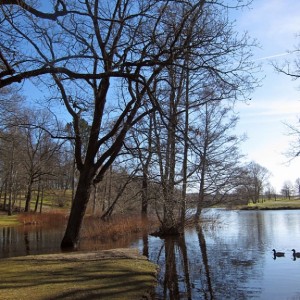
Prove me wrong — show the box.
[0,249,157,300]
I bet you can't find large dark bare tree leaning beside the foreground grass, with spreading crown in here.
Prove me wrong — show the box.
[0,0,253,248]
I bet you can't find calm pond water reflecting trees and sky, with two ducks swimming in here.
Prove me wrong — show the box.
[0,209,300,300]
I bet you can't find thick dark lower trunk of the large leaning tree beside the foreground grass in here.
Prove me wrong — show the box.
[61,167,93,249]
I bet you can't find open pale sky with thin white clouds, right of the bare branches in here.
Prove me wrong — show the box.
[236,0,300,192]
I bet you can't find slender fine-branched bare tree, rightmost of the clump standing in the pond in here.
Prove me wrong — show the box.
[194,101,244,220]
